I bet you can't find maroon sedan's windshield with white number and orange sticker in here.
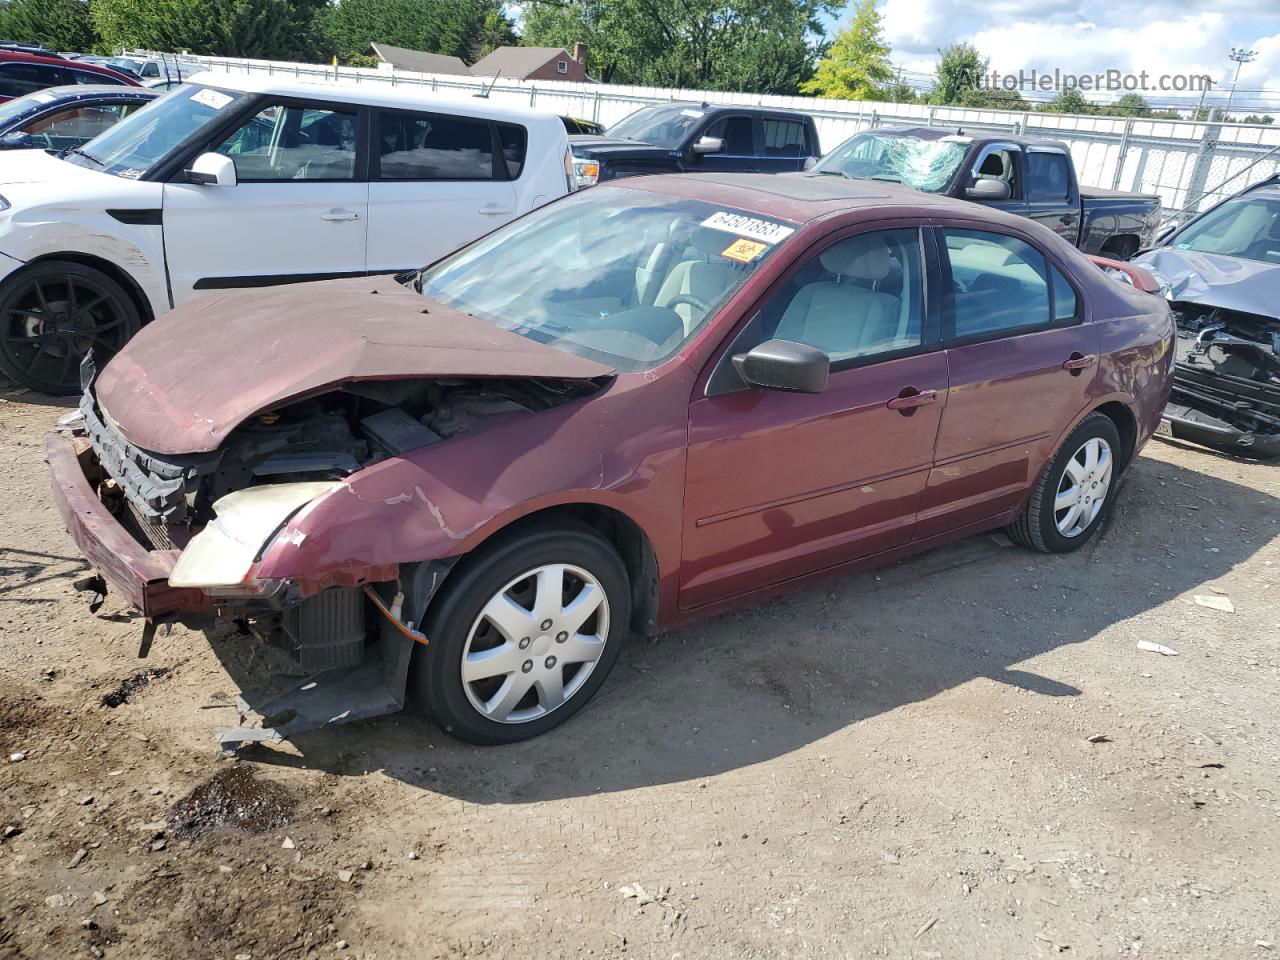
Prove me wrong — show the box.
[421,187,795,371]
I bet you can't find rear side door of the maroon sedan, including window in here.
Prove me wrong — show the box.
[916,228,1100,539]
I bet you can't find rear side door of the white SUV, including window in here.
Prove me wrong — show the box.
[369,109,517,273]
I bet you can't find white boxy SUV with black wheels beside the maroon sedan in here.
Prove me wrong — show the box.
[0,73,570,393]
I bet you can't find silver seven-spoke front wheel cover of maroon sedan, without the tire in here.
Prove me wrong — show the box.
[460,563,609,723]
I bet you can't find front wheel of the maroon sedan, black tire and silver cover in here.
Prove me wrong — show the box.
[410,524,631,745]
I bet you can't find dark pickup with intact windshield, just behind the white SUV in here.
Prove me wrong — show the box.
[568,104,822,187]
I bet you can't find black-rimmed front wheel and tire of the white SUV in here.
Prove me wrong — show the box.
[0,260,142,396]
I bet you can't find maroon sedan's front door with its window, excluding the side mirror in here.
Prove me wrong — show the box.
[680,227,947,609]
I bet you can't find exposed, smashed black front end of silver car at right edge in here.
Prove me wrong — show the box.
[1160,301,1280,460]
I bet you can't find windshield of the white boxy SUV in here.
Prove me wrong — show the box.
[67,86,248,180]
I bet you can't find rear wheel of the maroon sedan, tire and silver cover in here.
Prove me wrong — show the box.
[1006,413,1124,553]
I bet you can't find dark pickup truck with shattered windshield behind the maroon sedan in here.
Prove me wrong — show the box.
[813,127,1160,260]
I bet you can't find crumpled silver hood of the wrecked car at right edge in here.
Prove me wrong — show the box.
[1133,247,1280,319]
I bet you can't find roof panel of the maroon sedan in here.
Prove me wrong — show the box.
[607,173,1054,230]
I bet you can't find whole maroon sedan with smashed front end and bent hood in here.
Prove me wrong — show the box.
[49,174,1174,744]
